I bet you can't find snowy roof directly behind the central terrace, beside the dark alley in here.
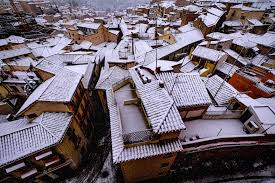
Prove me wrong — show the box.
[96,66,129,89]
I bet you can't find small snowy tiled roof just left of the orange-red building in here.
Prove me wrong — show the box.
[205,75,239,105]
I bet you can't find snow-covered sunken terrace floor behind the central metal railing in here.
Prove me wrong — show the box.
[114,84,148,134]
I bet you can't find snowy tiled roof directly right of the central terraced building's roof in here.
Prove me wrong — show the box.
[157,72,211,107]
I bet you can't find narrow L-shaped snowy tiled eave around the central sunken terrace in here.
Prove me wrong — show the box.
[106,89,182,163]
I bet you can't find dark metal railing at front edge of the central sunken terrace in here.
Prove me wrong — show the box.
[122,129,156,144]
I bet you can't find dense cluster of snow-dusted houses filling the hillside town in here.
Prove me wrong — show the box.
[0,0,275,182]
